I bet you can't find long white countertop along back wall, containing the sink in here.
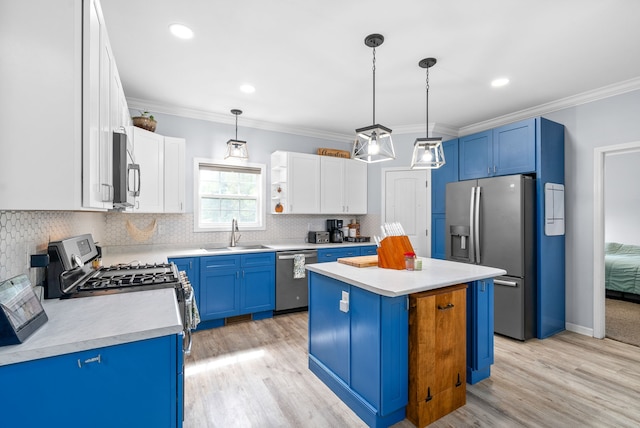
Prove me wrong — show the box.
[102,242,375,266]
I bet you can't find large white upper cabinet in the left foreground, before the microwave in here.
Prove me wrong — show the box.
[0,0,128,210]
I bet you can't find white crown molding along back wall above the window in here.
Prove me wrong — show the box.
[127,97,354,143]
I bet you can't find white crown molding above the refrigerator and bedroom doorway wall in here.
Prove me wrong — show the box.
[458,77,640,136]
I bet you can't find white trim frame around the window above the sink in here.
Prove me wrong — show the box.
[193,158,267,232]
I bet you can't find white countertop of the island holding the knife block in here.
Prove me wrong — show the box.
[306,257,507,297]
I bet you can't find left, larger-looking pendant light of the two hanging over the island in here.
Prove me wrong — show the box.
[351,34,396,163]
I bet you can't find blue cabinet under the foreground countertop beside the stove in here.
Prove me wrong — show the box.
[0,335,183,428]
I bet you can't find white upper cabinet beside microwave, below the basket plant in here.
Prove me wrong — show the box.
[133,127,164,213]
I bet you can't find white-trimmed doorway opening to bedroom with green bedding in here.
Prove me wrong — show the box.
[594,142,640,346]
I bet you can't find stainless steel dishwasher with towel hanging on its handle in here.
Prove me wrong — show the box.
[275,250,318,313]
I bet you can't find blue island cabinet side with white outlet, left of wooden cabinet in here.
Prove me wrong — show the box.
[309,272,408,427]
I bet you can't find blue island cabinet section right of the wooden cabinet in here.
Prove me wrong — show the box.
[467,279,494,384]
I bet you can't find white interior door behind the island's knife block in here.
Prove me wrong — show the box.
[382,169,431,257]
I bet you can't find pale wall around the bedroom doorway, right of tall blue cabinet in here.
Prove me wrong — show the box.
[544,91,640,329]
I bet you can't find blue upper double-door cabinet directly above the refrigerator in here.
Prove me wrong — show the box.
[460,119,536,180]
